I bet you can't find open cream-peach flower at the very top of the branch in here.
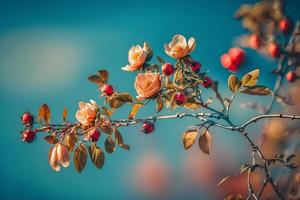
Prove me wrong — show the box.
[164,34,196,59]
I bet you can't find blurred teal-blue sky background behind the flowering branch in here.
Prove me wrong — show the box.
[0,0,300,199]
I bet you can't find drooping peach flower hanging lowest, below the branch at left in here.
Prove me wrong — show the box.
[49,143,70,171]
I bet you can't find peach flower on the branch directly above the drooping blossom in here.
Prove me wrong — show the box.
[76,100,98,126]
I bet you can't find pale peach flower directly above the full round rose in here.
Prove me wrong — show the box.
[122,43,149,72]
